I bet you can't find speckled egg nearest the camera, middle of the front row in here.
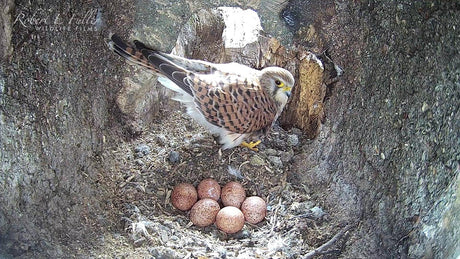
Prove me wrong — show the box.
[216,206,244,234]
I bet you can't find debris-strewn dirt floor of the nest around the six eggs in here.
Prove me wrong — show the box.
[92,108,345,258]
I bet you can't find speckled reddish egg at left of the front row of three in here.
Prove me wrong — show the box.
[190,198,220,227]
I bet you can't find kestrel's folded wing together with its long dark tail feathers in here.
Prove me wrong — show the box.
[109,34,277,134]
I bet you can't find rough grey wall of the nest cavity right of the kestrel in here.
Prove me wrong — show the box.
[291,1,460,258]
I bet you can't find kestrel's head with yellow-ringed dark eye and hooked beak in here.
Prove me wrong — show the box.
[261,67,295,109]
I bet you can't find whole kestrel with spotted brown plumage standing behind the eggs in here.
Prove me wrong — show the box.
[107,34,295,151]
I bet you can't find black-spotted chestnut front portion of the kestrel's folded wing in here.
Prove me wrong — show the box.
[190,74,276,134]
